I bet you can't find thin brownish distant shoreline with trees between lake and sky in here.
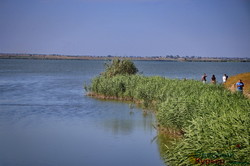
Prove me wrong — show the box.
[0,53,250,62]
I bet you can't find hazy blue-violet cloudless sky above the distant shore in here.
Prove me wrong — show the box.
[0,0,250,57]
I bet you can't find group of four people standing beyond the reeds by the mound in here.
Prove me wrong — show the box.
[201,73,244,92]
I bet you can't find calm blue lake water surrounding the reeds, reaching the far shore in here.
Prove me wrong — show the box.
[0,59,250,166]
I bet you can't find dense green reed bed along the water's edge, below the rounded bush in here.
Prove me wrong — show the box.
[88,75,250,166]
